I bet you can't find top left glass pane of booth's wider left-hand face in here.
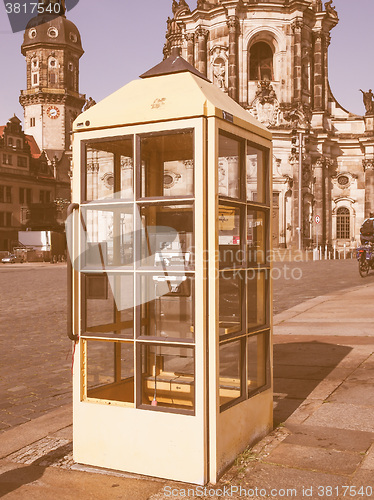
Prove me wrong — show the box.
[82,136,134,201]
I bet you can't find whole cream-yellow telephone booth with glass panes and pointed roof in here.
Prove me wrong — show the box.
[68,56,272,484]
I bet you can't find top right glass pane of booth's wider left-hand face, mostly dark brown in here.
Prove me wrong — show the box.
[137,129,194,198]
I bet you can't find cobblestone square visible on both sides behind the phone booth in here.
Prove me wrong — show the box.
[0,260,374,432]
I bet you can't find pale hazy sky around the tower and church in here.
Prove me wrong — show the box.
[0,0,374,125]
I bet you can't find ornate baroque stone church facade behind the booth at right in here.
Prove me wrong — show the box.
[164,0,374,249]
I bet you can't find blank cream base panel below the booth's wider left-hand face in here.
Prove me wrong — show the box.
[73,401,207,485]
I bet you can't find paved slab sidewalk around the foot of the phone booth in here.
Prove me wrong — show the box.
[0,284,374,500]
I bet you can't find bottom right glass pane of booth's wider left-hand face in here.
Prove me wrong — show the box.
[137,343,195,413]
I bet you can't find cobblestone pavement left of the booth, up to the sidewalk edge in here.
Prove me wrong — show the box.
[0,264,71,432]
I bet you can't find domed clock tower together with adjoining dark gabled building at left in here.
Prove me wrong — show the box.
[0,0,86,251]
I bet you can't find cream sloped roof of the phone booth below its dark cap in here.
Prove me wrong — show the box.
[73,67,271,140]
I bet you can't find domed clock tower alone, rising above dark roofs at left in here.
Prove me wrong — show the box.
[20,0,85,168]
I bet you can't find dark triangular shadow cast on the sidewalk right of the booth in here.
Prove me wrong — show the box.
[274,341,352,427]
